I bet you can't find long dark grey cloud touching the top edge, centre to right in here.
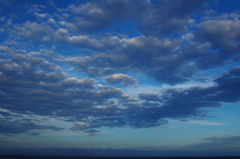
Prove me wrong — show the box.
[65,0,205,36]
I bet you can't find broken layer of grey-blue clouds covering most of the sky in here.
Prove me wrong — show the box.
[0,0,240,136]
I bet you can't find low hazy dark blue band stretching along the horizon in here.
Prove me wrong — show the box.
[0,148,240,157]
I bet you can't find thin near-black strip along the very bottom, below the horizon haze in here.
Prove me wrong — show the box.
[0,155,240,159]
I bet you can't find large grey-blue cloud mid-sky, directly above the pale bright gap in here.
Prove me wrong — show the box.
[67,37,189,84]
